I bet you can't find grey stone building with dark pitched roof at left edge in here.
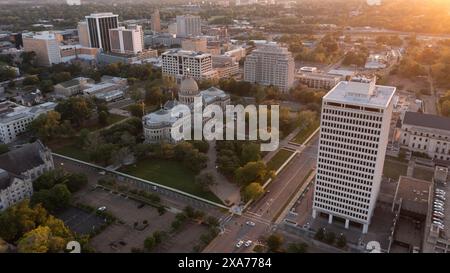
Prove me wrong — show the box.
[0,140,54,211]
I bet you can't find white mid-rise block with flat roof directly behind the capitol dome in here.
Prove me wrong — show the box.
[161,49,215,80]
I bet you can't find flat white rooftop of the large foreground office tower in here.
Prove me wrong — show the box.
[324,81,396,108]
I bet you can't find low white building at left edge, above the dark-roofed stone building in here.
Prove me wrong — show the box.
[0,101,56,143]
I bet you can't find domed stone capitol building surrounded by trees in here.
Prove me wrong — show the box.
[142,78,230,143]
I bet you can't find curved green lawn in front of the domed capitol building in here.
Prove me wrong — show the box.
[119,159,222,204]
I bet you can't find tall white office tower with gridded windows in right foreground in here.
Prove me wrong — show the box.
[313,79,396,233]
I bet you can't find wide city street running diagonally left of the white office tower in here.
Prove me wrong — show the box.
[203,134,319,253]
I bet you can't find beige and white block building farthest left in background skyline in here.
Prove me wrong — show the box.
[22,31,61,66]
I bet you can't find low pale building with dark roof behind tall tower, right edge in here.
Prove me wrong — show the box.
[400,112,450,161]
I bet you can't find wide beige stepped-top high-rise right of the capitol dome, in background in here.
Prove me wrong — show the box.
[244,42,295,92]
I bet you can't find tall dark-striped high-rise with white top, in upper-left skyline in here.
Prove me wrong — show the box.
[86,12,119,51]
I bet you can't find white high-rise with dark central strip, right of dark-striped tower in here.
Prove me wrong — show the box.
[109,25,144,54]
